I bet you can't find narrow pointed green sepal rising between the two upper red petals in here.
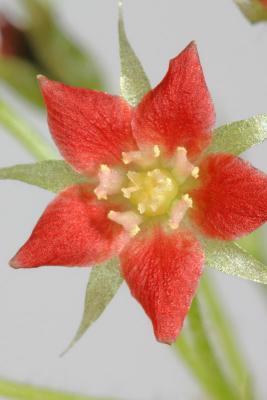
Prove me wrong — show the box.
[118,1,151,106]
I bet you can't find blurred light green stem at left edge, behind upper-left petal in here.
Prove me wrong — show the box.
[0,101,57,160]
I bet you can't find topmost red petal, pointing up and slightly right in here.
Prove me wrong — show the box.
[133,43,215,157]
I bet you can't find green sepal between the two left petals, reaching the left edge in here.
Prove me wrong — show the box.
[0,160,89,192]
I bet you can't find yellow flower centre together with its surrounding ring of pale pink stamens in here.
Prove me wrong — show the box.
[94,145,199,236]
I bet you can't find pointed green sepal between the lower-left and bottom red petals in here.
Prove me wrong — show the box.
[62,259,123,355]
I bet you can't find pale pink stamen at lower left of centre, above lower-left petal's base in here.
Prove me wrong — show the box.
[108,211,143,236]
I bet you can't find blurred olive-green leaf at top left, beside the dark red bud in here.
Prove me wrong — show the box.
[23,0,103,90]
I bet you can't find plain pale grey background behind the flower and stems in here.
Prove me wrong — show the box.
[0,0,267,400]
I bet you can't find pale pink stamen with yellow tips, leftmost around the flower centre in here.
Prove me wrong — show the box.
[94,164,124,200]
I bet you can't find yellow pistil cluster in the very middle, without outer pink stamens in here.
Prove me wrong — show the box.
[122,168,178,216]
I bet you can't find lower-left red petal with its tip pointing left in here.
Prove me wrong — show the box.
[10,186,130,268]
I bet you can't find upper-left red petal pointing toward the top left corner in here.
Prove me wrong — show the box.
[40,77,136,172]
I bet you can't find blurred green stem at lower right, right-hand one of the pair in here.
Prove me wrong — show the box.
[199,276,253,399]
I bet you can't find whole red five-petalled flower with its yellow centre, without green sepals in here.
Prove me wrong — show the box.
[8,43,267,343]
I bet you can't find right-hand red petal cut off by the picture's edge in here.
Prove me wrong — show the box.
[191,154,267,240]
